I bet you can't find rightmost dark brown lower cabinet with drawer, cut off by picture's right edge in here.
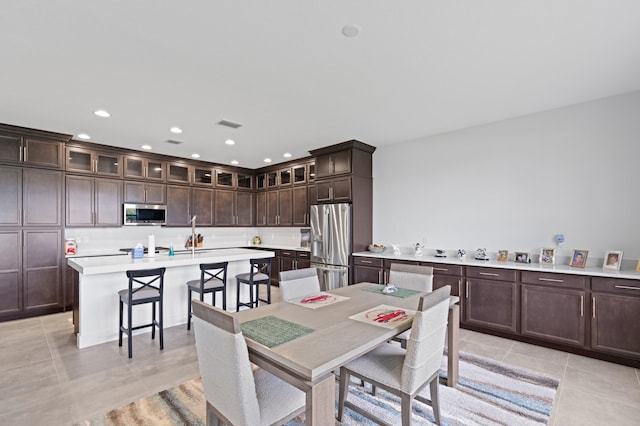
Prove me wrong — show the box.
[591,277,640,360]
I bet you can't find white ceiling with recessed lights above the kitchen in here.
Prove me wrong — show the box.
[0,0,640,168]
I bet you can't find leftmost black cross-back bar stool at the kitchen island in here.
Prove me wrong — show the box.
[118,268,167,358]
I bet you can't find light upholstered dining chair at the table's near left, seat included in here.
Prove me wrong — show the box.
[193,300,306,425]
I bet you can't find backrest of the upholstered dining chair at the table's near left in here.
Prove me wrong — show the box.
[193,300,261,425]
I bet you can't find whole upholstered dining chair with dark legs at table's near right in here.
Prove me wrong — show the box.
[338,286,451,426]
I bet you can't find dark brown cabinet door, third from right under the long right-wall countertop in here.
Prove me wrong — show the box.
[464,278,518,333]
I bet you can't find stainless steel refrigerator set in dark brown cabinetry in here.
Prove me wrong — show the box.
[310,203,352,290]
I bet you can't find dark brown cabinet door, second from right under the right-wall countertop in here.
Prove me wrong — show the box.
[520,284,586,347]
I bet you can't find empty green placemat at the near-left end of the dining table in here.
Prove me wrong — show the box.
[240,315,315,348]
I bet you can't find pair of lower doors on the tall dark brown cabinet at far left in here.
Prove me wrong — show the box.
[0,229,64,319]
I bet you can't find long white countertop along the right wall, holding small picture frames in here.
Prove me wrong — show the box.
[353,251,640,280]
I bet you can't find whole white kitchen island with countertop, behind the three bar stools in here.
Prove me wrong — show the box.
[67,248,275,348]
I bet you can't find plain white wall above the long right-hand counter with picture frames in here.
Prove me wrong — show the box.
[373,92,640,266]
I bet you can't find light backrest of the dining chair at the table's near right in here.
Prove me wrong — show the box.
[401,285,451,394]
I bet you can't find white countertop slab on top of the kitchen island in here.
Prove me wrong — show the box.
[67,248,275,275]
